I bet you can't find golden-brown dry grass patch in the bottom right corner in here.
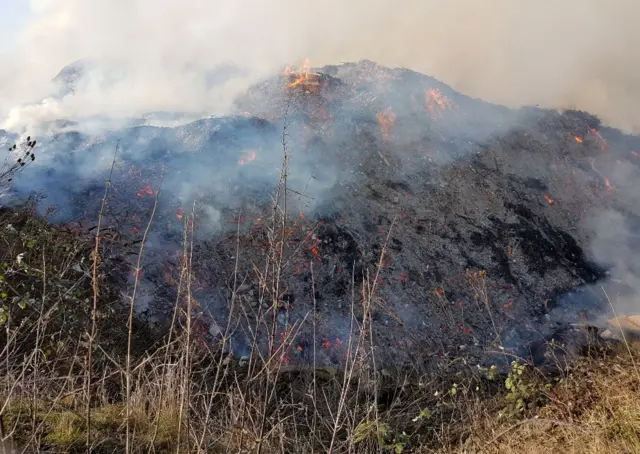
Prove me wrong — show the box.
[443,344,640,454]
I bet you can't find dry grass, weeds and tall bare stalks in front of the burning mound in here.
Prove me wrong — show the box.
[0,206,640,454]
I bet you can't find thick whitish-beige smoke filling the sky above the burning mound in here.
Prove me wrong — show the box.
[0,0,640,131]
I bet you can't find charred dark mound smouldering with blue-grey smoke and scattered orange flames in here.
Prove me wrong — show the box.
[7,61,640,367]
